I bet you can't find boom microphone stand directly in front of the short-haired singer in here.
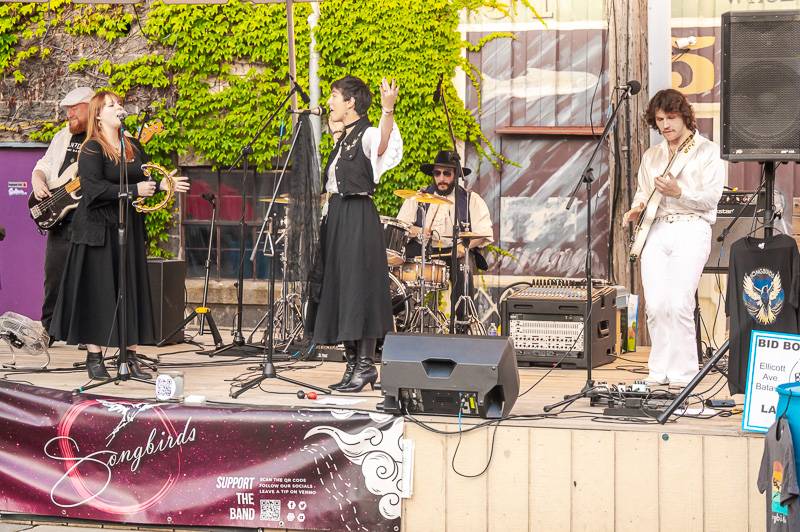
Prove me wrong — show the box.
[231,120,331,399]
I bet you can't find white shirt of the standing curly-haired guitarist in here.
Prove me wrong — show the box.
[633,133,728,225]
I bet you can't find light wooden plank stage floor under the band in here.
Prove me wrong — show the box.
[0,335,742,435]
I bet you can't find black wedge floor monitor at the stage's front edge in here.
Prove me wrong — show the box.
[381,333,519,419]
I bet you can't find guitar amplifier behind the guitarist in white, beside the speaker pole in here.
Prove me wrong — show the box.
[703,191,764,273]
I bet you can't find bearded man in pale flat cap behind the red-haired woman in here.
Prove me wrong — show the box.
[31,87,94,342]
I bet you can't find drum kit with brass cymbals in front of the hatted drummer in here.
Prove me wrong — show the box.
[248,189,489,352]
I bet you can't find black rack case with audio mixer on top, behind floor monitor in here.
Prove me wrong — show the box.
[501,278,617,369]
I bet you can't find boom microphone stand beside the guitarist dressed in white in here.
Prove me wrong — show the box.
[544,87,631,412]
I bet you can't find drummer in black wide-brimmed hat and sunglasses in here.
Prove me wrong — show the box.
[397,150,493,319]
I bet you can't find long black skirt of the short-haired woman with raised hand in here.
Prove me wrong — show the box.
[314,194,392,344]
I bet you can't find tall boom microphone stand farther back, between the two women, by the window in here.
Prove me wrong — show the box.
[200,78,300,357]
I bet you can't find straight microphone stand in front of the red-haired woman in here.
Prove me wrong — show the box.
[74,120,155,393]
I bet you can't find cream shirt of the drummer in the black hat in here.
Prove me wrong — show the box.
[397,189,494,247]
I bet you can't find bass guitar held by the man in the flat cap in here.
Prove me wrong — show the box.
[28,120,164,231]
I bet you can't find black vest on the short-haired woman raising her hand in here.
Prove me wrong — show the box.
[323,116,375,196]
